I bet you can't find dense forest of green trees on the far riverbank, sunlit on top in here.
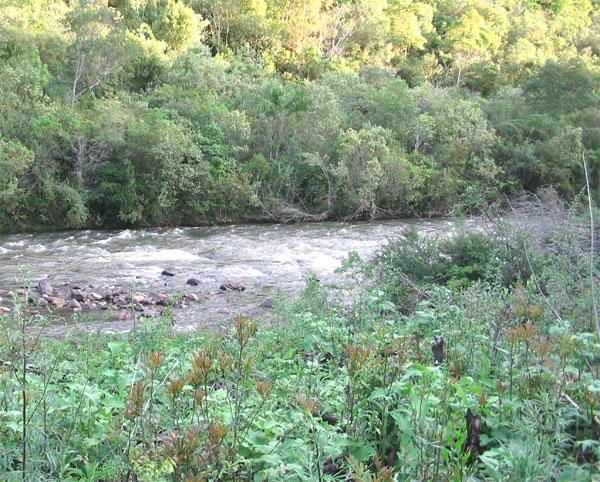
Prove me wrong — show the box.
[0,0,600,231]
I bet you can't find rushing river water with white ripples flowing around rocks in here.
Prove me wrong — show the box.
[0,219,477,334]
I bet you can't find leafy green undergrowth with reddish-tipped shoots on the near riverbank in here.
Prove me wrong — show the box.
[0,213,600,481]
